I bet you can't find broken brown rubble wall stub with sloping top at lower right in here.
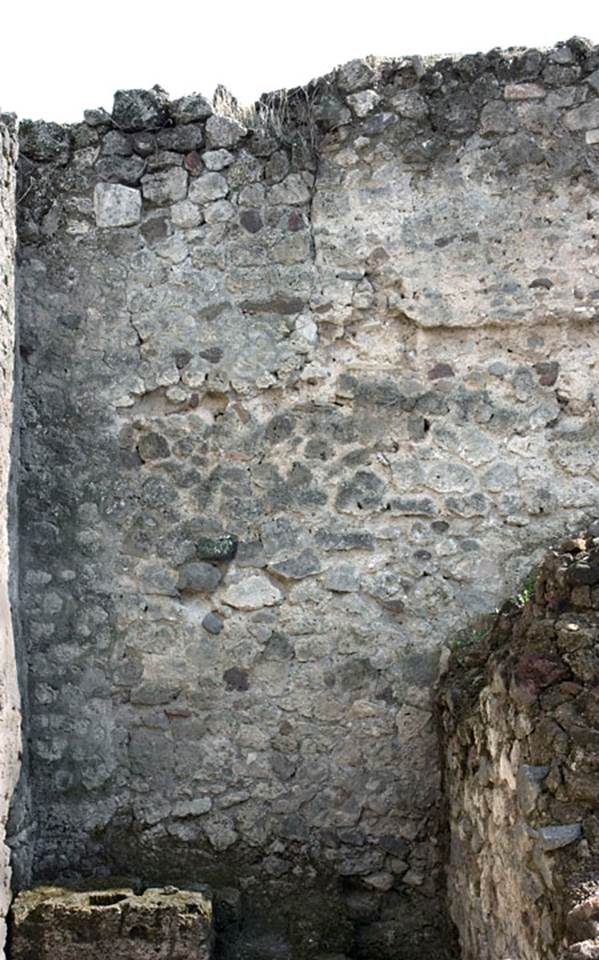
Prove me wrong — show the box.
[441,522,599,960]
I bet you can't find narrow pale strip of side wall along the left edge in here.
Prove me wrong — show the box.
[0,114,21,957]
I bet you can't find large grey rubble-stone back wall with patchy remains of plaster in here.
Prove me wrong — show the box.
[3,31,599,960]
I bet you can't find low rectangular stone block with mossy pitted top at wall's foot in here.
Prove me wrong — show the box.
[11,887,213,960]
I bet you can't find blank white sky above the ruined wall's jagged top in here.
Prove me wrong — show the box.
[0,0,599,122]
